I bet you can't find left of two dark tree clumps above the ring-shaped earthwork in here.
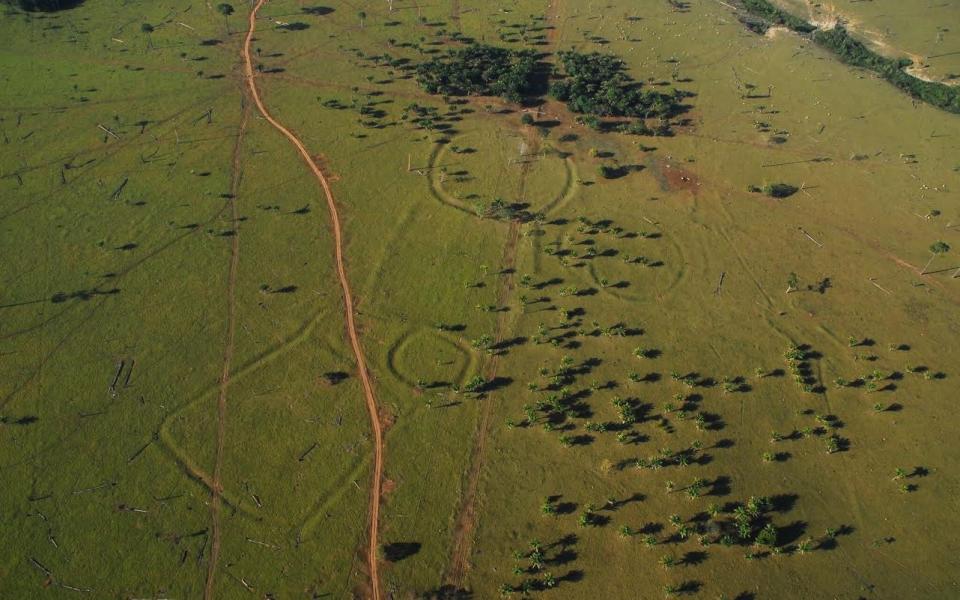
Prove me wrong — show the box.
[417,44,537,102]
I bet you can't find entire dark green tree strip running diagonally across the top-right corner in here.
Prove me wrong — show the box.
[740,0,960,114]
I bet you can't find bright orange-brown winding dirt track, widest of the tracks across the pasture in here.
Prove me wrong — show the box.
[243,0,383,600]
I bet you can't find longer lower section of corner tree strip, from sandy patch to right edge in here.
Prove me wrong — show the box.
[813,26,960,113]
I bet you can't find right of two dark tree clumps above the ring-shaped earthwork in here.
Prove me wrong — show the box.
[550,52,686,118]
